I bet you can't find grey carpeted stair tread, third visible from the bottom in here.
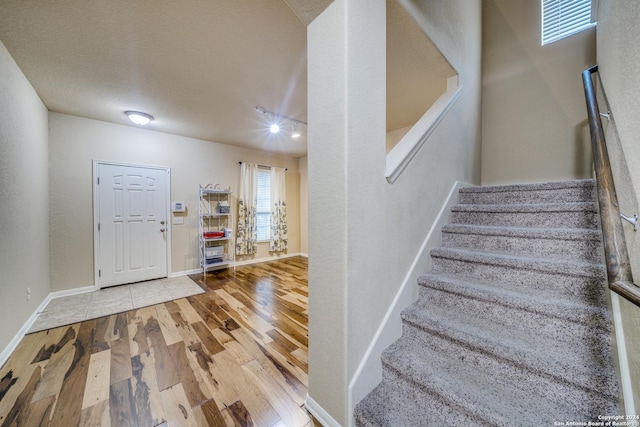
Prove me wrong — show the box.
[402,305,617,396]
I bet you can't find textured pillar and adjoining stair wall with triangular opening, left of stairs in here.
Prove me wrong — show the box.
[308,0,481,426]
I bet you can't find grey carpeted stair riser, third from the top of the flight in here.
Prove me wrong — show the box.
[442,232,601,262]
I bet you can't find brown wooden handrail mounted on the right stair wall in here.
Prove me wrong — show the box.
[582,65,640,307]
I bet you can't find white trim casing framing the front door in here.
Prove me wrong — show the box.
[92,159,171,291]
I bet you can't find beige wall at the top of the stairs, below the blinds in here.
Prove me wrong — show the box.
[482,0,595,185]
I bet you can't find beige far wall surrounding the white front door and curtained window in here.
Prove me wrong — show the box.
[49,112,300,291]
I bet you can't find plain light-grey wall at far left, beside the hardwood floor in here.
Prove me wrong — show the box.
[0,43,50,350]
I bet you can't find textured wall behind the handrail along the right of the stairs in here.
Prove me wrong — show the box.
[597,0,640,411]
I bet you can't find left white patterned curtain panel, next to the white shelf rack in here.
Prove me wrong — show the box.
[236,162,258,255]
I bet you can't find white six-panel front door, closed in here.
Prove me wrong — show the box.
[94,162,169,288]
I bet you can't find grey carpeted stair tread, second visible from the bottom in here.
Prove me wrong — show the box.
[382,339,597,426]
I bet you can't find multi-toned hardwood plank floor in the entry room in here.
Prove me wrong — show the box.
[0,257,313,427]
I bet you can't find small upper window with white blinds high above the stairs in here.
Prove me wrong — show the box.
[541,0,596,46]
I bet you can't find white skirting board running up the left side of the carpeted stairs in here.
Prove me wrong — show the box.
[348,181,471,425]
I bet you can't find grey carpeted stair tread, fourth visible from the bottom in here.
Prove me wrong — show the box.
[418,273,611,331]
